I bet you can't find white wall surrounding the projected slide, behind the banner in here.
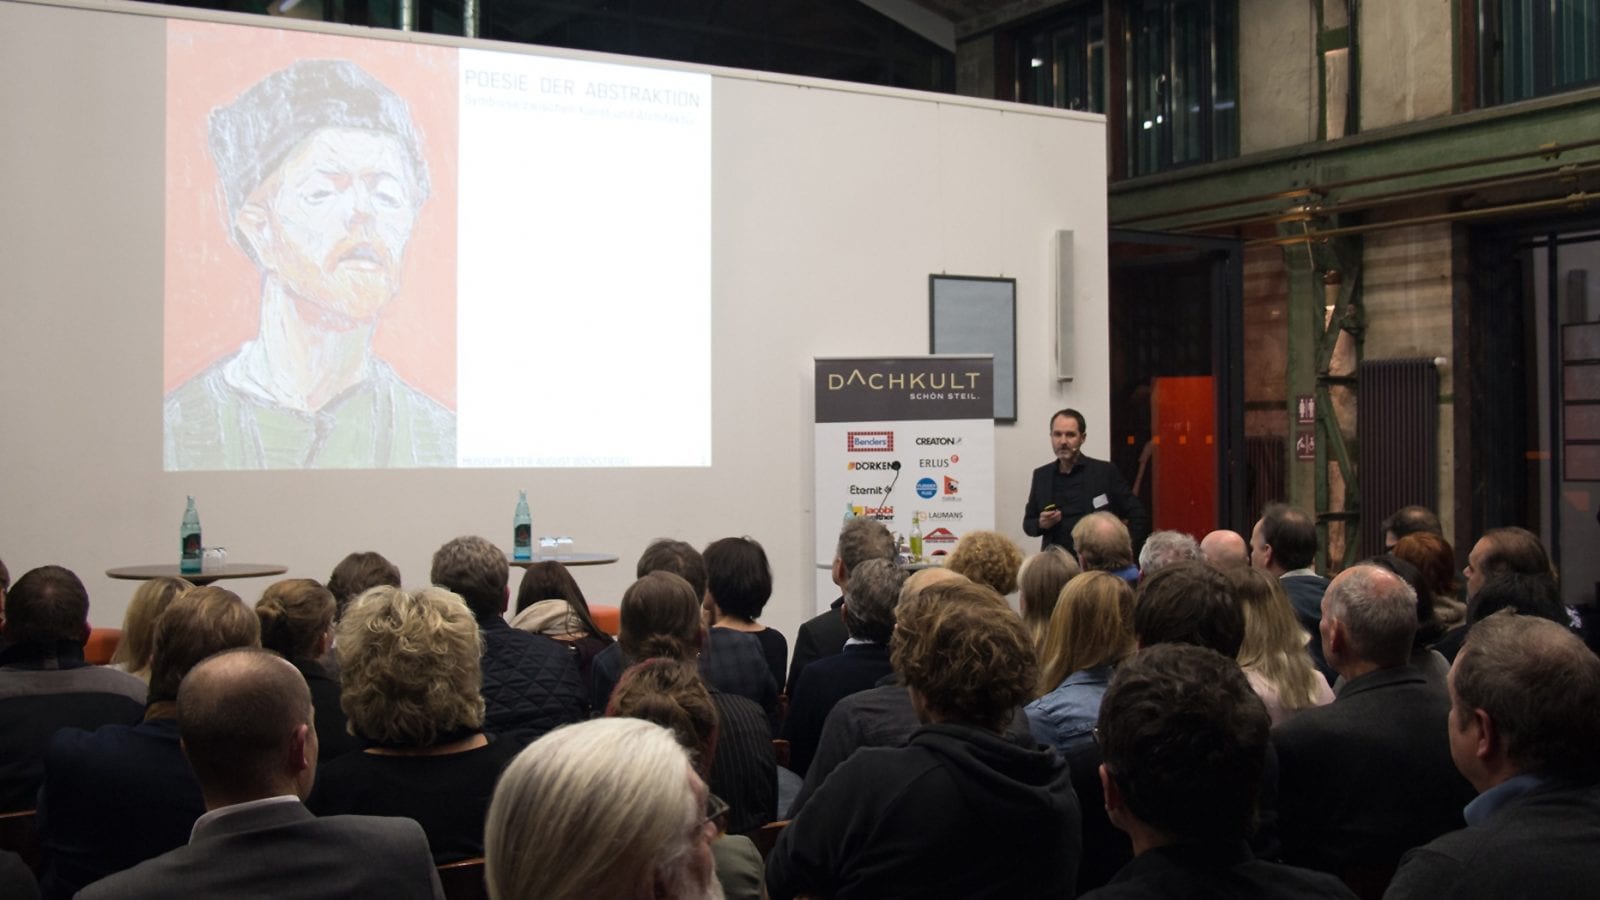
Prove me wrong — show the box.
[0,0,1109,634]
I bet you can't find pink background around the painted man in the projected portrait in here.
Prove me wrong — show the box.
[162,21,456,408]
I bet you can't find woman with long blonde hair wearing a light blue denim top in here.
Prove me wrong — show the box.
[1026,570,1139,754]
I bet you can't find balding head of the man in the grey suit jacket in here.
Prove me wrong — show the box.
[178,649,317,809]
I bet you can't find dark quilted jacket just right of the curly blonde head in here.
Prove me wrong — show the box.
[478,615,589,743]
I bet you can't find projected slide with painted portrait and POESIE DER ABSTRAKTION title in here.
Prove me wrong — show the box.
[163,21,710,471]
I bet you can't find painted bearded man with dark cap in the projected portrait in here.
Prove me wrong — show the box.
[163,59,456,469]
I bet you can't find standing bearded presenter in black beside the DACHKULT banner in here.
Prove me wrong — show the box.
[1022,410,1150,556]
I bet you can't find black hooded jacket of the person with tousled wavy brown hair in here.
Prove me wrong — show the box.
[766,724,1078,900]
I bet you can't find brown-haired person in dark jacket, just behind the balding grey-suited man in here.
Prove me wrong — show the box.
[38,585,261,900]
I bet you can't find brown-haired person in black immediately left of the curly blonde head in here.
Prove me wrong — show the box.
[256,578,362,762]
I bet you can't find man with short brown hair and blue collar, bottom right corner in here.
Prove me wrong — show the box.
[1384,612,1600,900]
